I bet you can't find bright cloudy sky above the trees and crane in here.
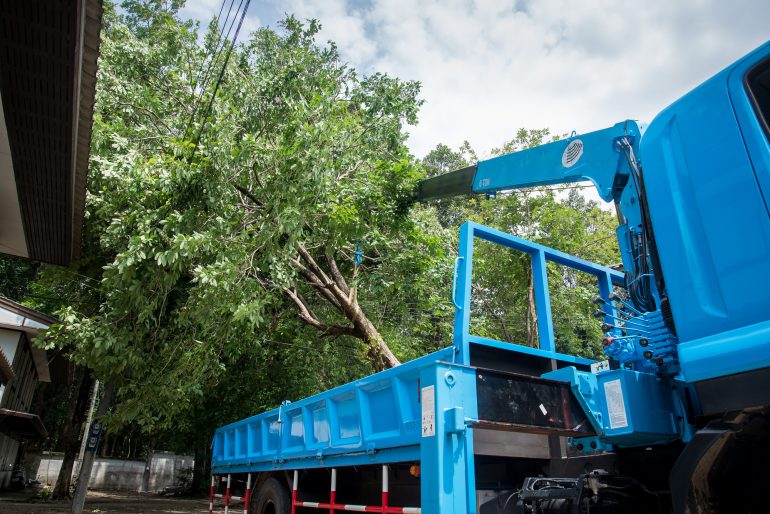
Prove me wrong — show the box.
[182,0,770,158]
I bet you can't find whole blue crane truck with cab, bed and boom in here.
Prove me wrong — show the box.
[211,43,770,514]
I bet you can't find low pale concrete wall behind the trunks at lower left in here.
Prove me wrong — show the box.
[25,452,195,492]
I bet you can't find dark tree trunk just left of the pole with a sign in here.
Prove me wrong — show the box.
[51,368,93,500]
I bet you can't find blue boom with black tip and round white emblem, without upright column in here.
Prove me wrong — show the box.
[415,120,641,202]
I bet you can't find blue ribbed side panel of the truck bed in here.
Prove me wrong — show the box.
[212,348,453,473]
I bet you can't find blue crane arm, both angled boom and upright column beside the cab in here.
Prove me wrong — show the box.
[415,120,663,312]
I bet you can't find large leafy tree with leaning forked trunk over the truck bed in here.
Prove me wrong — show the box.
[37,2,446,432]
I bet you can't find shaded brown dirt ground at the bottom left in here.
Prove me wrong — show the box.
[0,491,213,514]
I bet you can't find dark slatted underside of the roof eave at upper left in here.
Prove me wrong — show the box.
[0,0,102,264]
